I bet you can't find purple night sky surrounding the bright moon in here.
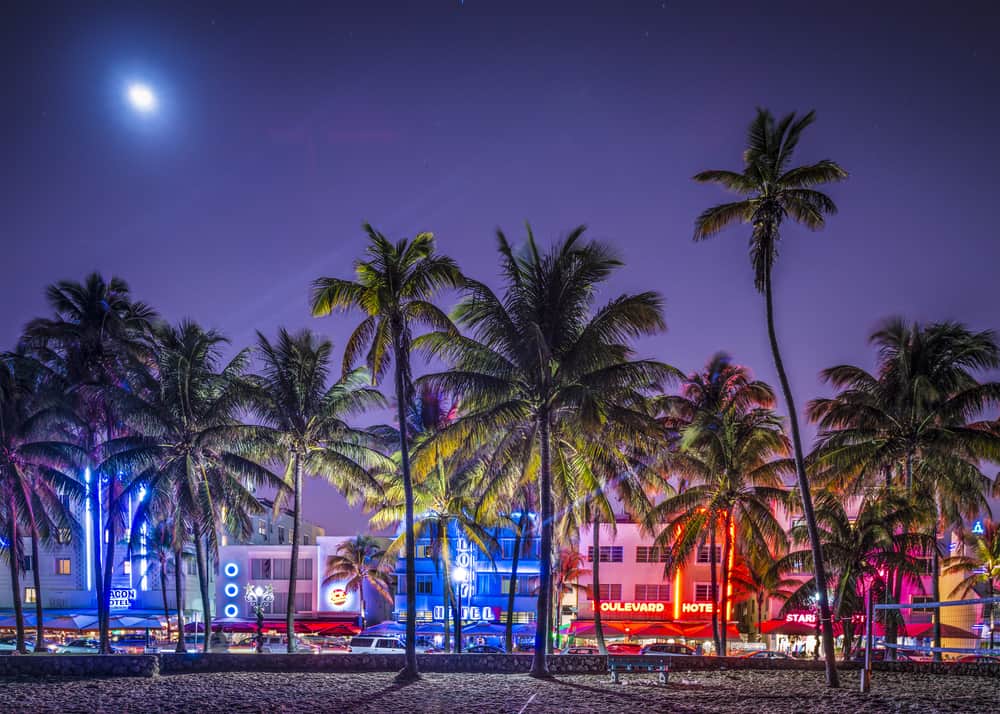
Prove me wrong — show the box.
[0,0,1000,533]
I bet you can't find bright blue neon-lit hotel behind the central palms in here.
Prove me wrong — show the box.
[393,516,539,624]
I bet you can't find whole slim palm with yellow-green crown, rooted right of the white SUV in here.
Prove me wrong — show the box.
[312,223,462,681]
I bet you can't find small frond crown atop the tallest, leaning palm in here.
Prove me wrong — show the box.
[694,109,847,291]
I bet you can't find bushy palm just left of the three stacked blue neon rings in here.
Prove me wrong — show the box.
[110,321,284,652]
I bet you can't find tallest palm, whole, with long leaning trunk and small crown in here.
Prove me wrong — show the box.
[694,109,847,687]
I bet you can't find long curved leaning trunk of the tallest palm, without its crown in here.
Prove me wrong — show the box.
[764,267,840,688]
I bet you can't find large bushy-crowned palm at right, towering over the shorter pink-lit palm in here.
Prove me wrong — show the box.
[807,318,1000,658]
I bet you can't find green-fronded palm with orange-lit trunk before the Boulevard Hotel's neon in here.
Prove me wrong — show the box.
[649,403,791,656]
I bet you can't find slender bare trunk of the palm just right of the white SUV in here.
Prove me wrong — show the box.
[392,334,420,682]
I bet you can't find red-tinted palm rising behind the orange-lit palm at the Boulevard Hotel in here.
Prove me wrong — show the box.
[650,352,775,652]
